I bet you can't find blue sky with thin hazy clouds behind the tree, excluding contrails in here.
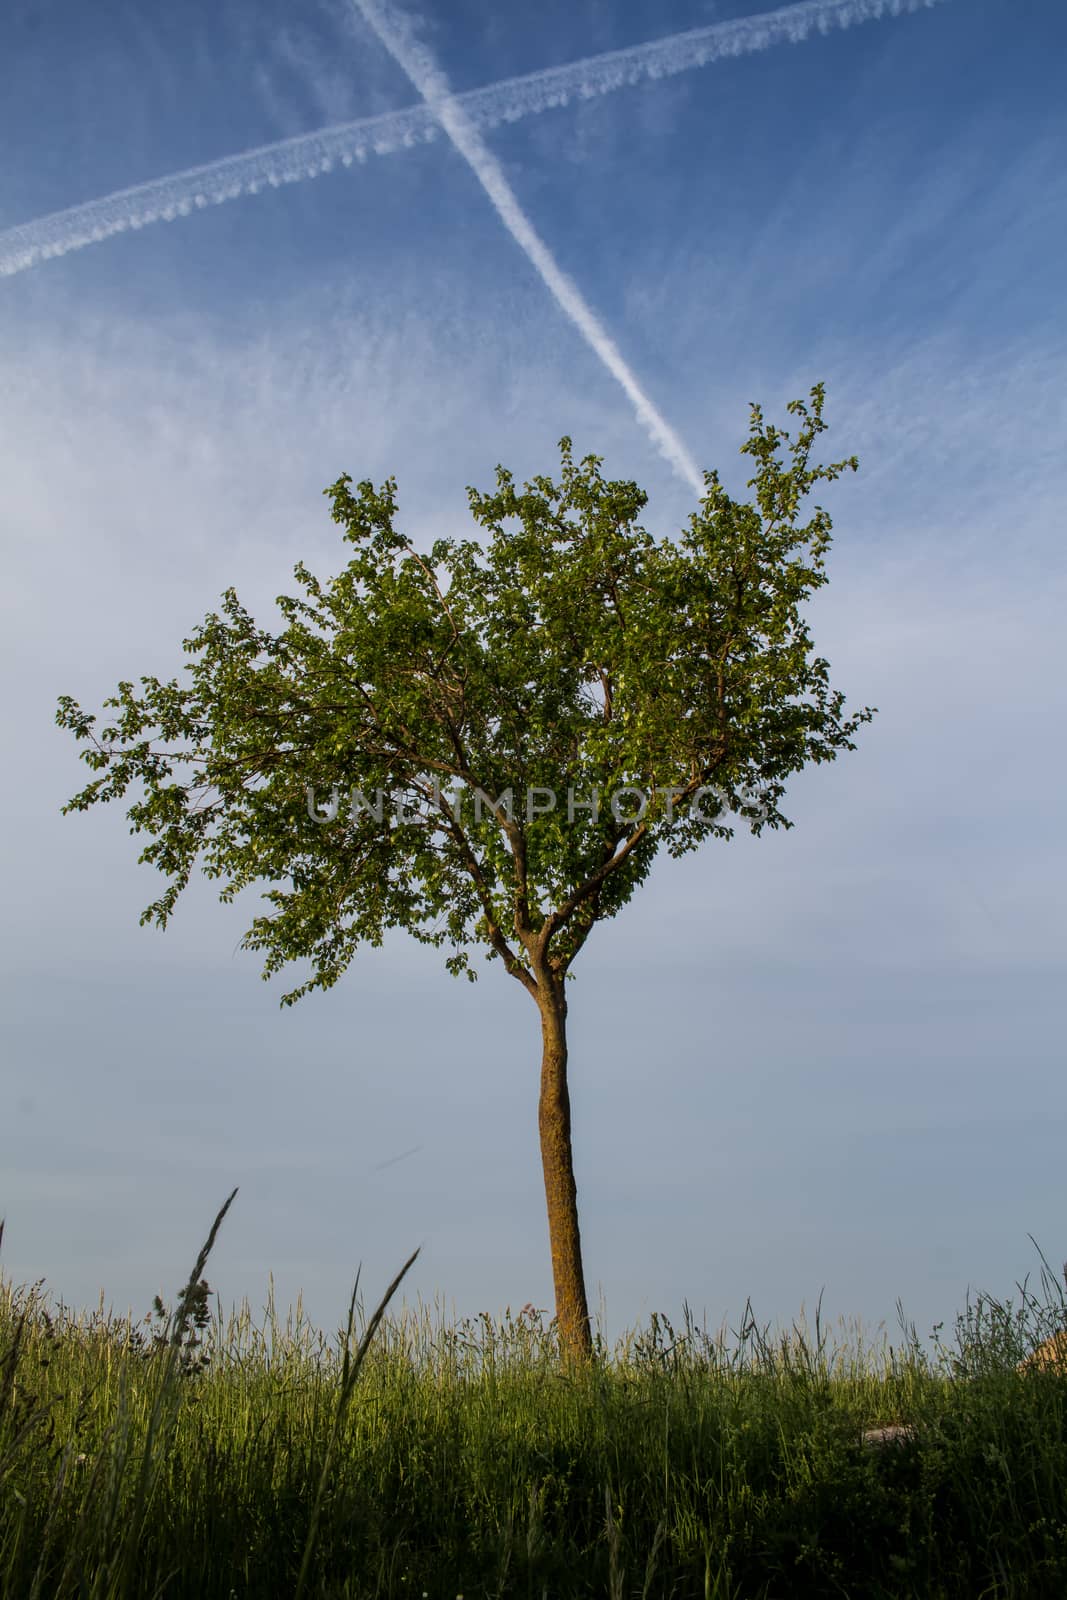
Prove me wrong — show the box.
[0,0,1067,1369]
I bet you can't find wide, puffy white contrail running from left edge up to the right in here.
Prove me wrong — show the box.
[0,0,945,277]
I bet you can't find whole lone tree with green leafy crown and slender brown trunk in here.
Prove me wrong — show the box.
[56,384,873,1358]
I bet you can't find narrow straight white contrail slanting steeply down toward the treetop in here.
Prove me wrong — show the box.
[354,0,704,498]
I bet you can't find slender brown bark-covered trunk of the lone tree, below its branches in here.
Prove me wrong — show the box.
[537,973,593,1362]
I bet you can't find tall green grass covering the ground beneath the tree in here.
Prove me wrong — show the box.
[0,1190,1067,1600]
